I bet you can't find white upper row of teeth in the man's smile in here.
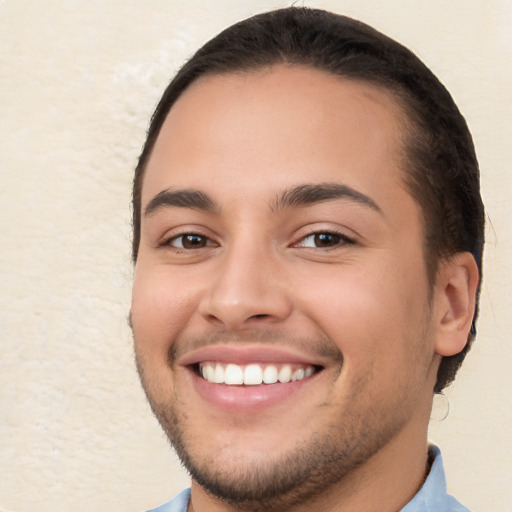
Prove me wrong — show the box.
[199,363,315,386]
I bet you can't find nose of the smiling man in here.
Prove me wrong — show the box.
[199,244,292,331]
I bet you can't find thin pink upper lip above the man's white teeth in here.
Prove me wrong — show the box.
[179,345,327,366]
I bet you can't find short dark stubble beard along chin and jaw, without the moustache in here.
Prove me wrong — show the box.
[139,368,412,512]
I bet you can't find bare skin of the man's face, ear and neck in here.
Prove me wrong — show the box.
[131,66,478,512]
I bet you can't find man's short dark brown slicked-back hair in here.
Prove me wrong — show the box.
[132,8,484,392]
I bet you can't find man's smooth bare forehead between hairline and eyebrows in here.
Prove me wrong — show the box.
[142,66,405,214]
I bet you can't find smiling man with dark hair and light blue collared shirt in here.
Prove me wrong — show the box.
[131,8,483,512]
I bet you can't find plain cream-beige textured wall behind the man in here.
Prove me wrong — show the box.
[0,0,512,512]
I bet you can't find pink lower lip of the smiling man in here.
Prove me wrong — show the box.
[190,371,320,414]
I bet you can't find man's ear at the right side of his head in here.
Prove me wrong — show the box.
[435,252,480,356]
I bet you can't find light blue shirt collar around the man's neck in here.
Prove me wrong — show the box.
[148,446,470,512]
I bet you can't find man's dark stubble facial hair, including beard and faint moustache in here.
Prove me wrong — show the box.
[134,326,432,512]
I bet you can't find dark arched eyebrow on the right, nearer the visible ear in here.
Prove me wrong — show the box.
[271,183,382,214]
